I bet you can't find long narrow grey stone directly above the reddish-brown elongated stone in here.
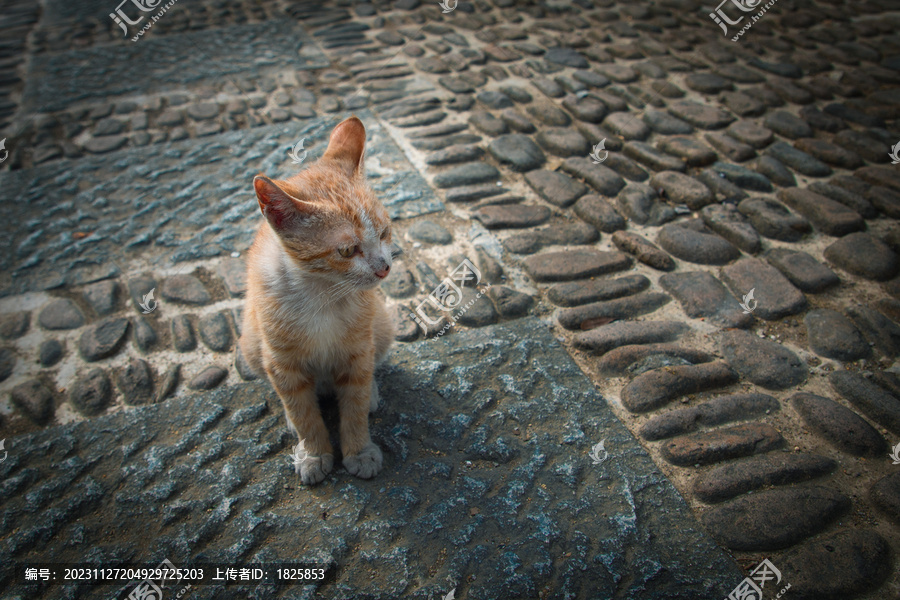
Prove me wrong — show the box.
[640,394,781,442]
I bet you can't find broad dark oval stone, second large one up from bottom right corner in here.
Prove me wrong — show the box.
[701,486,850,551]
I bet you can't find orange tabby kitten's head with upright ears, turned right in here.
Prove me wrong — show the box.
[253,117,391,288]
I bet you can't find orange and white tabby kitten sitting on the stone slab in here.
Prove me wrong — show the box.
[240,117,394,484]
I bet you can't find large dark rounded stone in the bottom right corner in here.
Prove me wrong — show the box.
[778,532,896,599]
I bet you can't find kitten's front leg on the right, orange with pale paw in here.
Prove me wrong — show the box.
[335,354,382,479]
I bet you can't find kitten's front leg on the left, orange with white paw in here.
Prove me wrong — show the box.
[268,369,334,485]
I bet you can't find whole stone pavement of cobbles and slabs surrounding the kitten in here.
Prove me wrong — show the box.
[0,0,900,600]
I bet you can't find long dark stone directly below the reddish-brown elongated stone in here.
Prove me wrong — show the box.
[694,452,837,504]
